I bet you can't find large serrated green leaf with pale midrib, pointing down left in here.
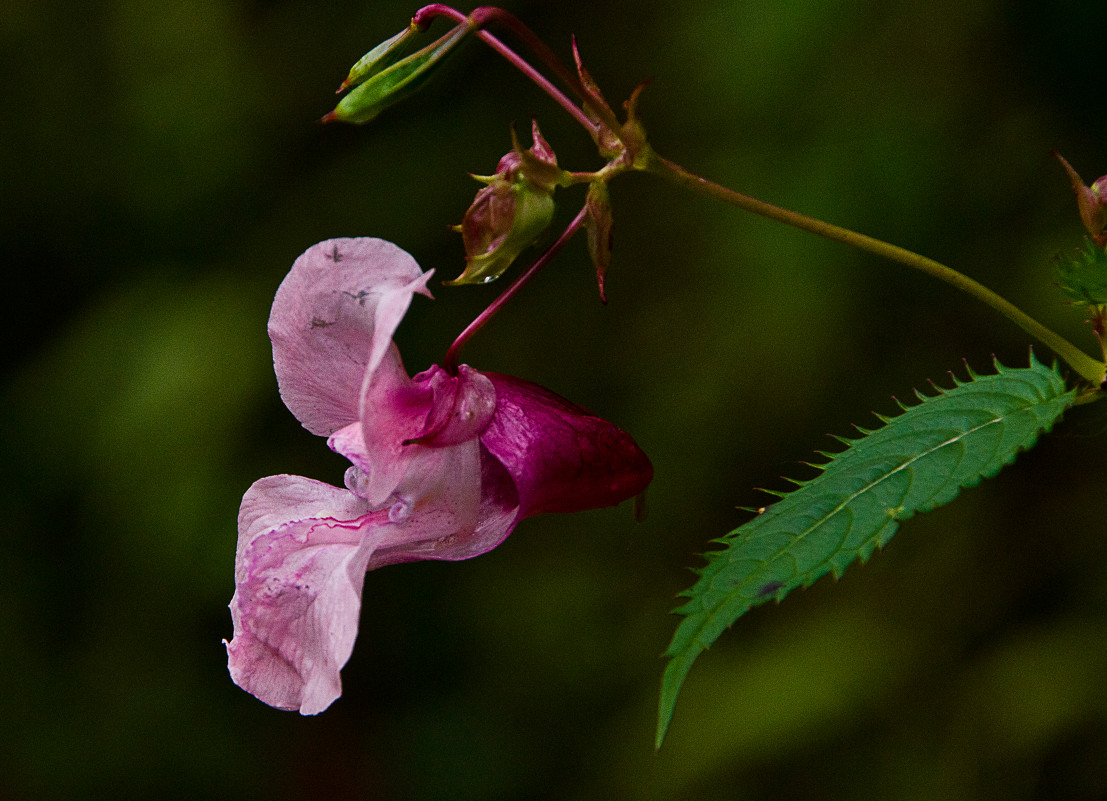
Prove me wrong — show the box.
[656,356,1076,748]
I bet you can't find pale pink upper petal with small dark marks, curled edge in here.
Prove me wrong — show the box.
[269,237,430,436]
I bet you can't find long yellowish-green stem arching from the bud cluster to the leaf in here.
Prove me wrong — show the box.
[634,148,1104,386]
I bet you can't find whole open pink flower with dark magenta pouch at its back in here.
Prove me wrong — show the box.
[227,238,652,715]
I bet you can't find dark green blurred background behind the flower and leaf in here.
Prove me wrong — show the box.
[0,0,1107,801]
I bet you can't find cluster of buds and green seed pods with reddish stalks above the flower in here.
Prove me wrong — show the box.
[323,4,651,303]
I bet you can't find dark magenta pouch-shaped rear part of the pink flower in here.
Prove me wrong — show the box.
[480,373,653,517]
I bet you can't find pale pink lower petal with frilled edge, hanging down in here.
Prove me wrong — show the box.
[227,476,392,715]
